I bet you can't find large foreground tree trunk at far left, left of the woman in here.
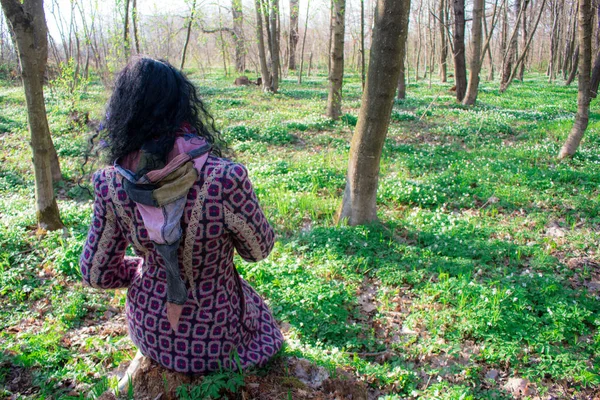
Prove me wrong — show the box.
[0,0,63,230]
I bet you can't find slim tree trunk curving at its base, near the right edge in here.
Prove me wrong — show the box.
[558,0,592,159]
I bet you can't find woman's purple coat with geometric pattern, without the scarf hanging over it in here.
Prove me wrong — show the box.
[80,156,283,373]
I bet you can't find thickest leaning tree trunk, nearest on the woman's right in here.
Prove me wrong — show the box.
[337,0,407,225]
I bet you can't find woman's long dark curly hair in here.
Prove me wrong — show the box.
[100,57,223,163]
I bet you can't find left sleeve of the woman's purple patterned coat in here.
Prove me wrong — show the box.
[79,171,142,289]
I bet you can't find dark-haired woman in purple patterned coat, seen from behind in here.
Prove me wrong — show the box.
[80,58,283,373]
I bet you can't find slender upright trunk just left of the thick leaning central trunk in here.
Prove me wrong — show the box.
[327,0,346,119]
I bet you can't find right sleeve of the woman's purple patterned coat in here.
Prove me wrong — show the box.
[223,164,275,262]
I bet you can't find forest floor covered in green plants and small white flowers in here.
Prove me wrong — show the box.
[0,73,600,400]
